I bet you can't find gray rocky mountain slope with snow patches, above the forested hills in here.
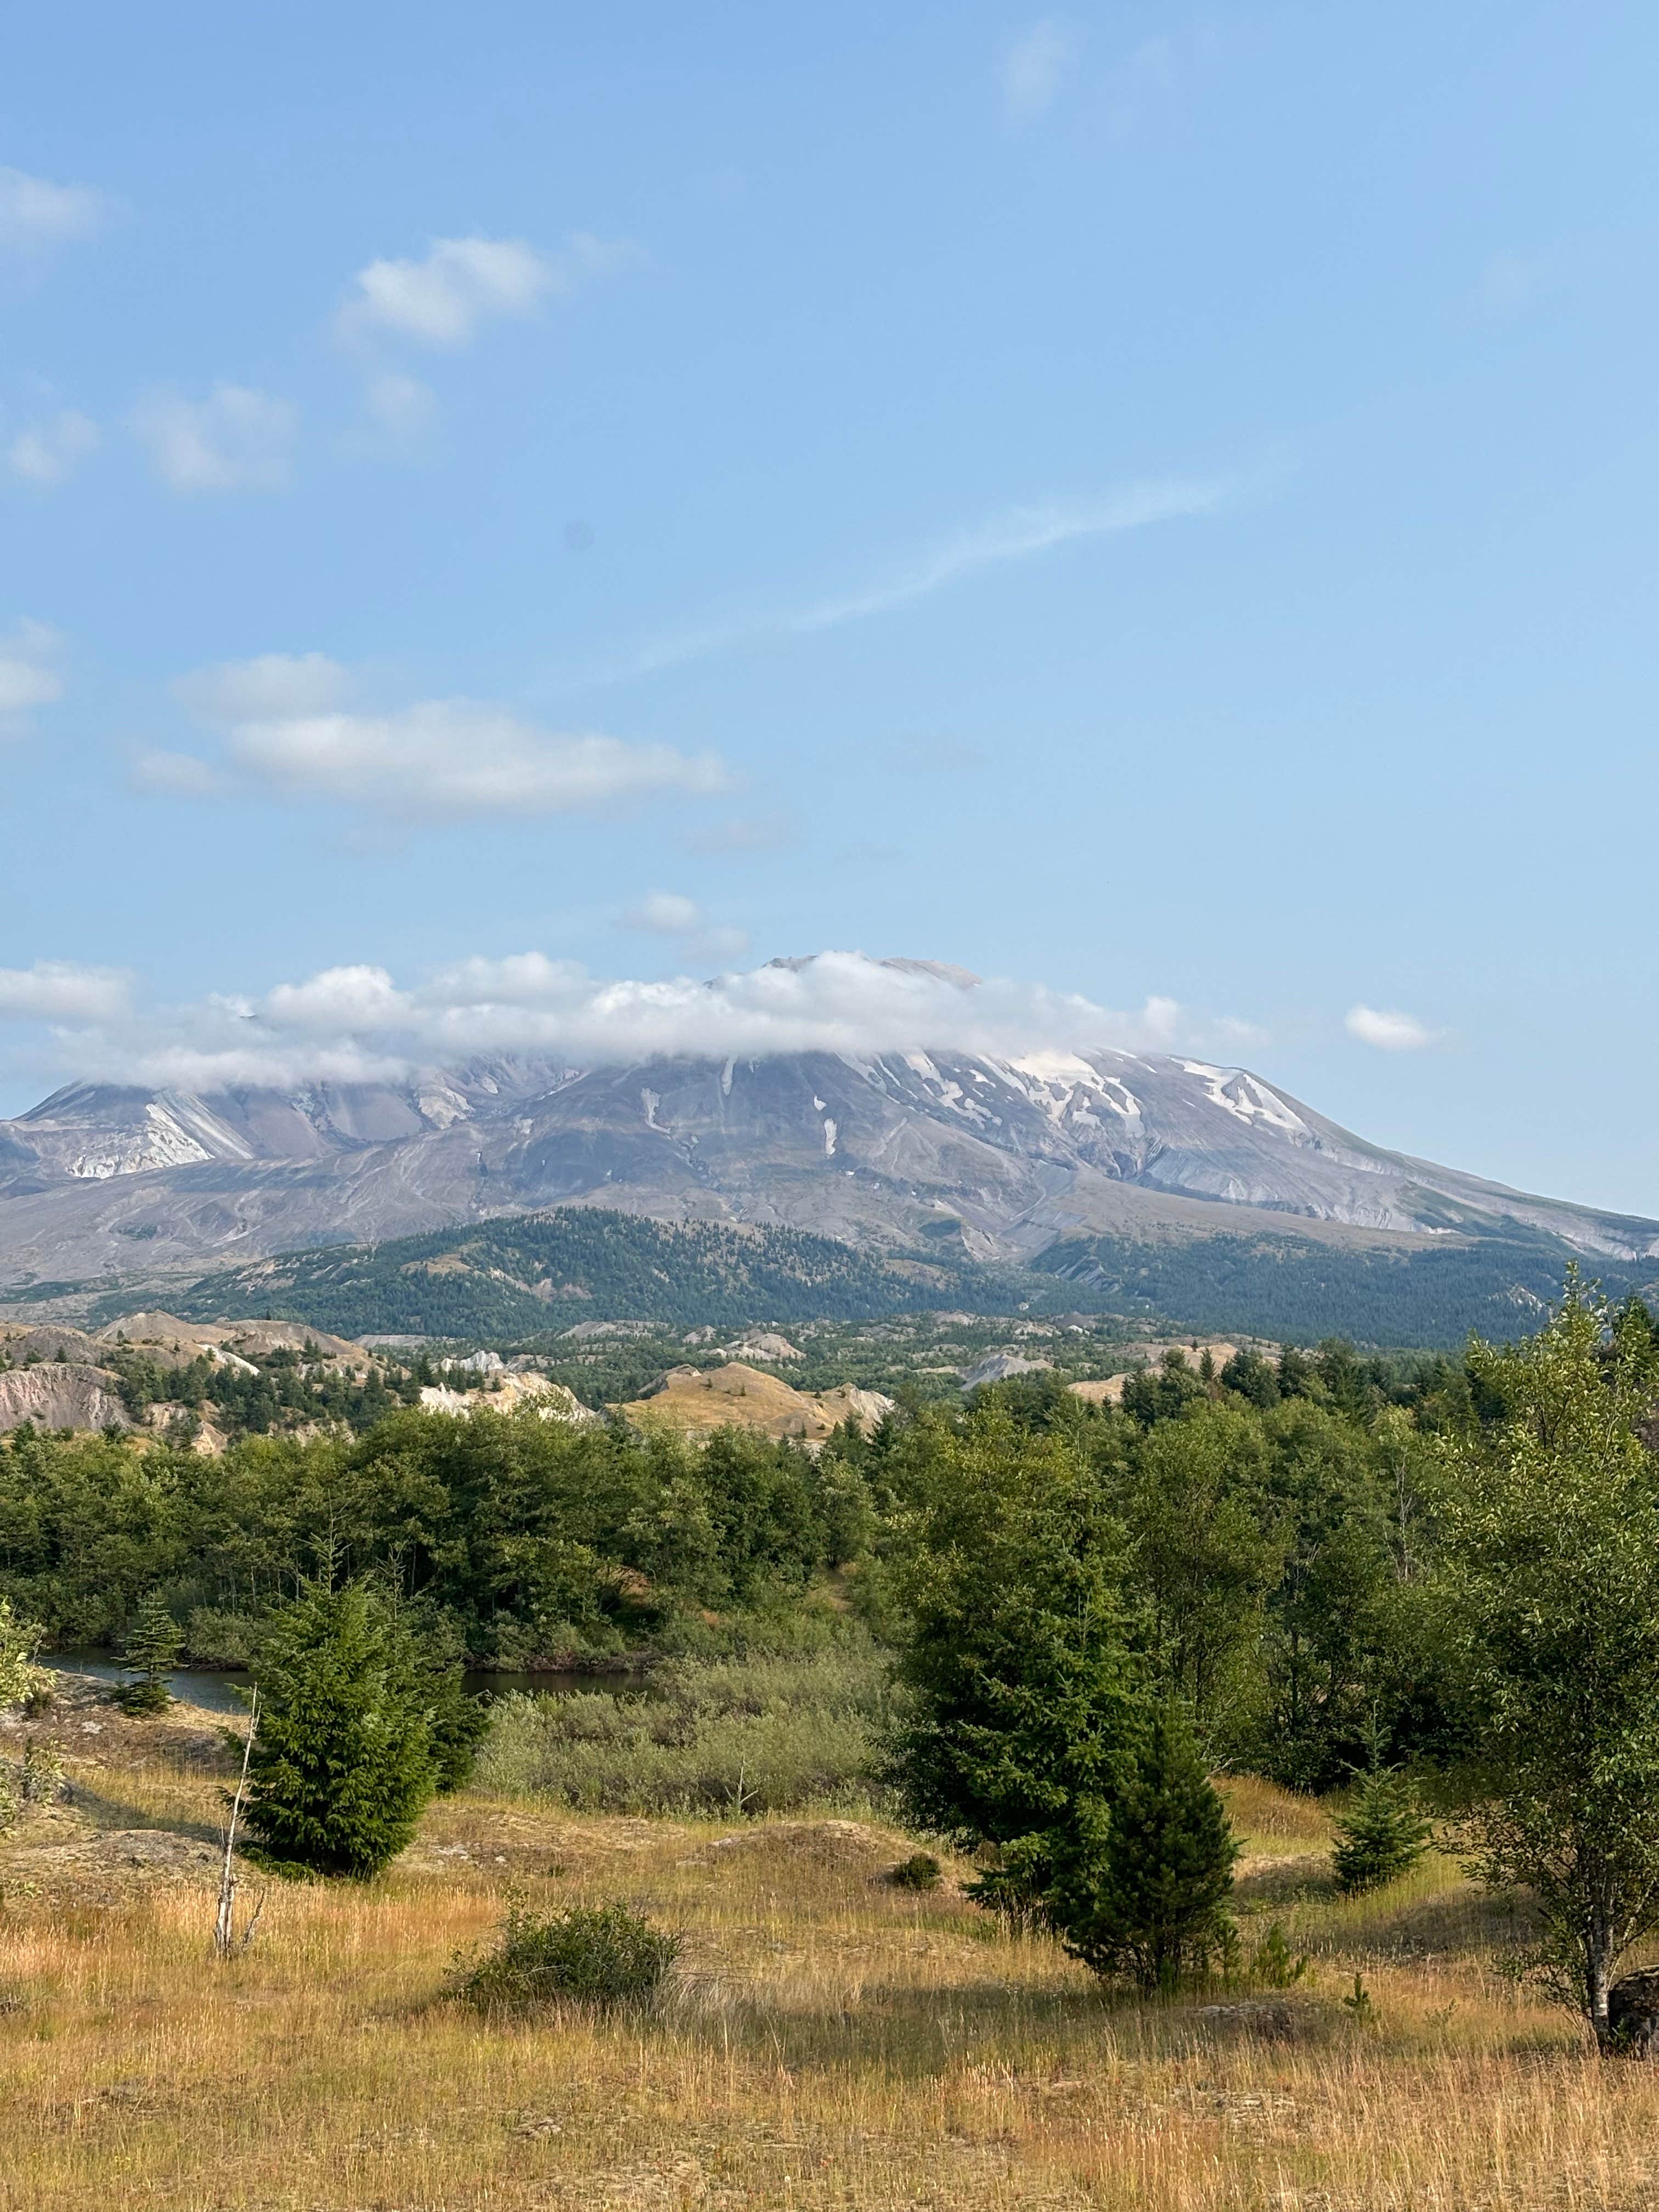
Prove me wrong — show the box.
[0,1051,1659,1285]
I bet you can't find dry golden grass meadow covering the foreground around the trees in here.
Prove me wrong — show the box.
[0,1690,1659,2212]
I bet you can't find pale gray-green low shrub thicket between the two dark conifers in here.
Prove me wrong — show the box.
[478,1637,887,1816]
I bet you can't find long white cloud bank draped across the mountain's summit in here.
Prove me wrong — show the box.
[13,951,1238,1088]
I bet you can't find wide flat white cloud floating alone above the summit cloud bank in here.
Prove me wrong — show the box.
[159,652,732,821]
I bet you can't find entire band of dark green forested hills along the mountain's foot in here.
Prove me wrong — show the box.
[123,1205,1659,1347]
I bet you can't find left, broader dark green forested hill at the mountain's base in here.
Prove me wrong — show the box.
[159,1205,1007,1338]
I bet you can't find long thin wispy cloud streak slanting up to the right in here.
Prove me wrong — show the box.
[600,478,1232,681]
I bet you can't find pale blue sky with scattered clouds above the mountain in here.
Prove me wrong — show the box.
[0,0,1659,1215]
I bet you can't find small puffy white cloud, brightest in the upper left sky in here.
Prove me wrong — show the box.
[338,232,639,352]
